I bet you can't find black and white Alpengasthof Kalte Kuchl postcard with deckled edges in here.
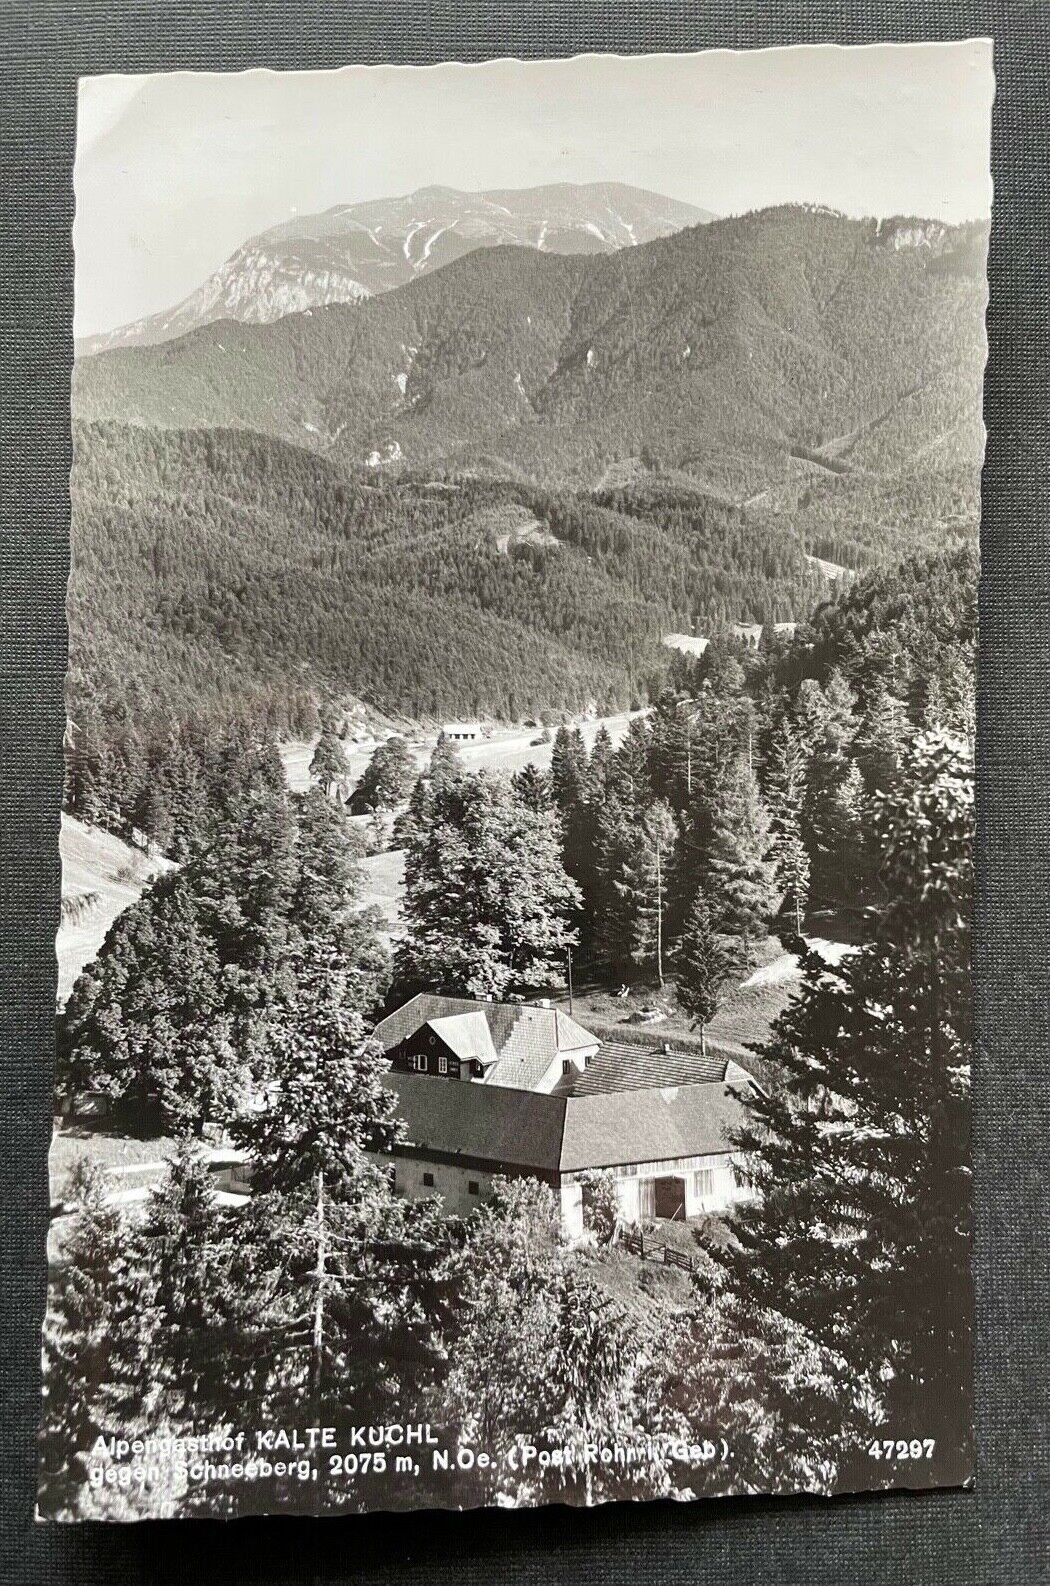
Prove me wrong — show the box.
[41,40,994,1521]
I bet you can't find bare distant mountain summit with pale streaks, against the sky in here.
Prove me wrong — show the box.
[78,182,714,355]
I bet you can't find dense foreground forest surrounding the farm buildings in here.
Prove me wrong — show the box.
[51,550,975,1518]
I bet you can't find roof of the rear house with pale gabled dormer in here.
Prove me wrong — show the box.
[376,991,598,1090]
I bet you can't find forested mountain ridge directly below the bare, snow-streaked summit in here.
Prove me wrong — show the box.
[75,206,987,508]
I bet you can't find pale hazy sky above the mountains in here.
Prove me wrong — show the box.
[73,41,993,335]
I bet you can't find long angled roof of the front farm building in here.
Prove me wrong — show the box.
[385,1066,749,1174]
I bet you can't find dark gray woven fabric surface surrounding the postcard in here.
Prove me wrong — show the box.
[0,0,1050,1586]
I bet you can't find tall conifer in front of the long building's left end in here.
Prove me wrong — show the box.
[233,950,444,1507]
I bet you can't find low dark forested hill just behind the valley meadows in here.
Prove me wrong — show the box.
[68,423,828,733]
